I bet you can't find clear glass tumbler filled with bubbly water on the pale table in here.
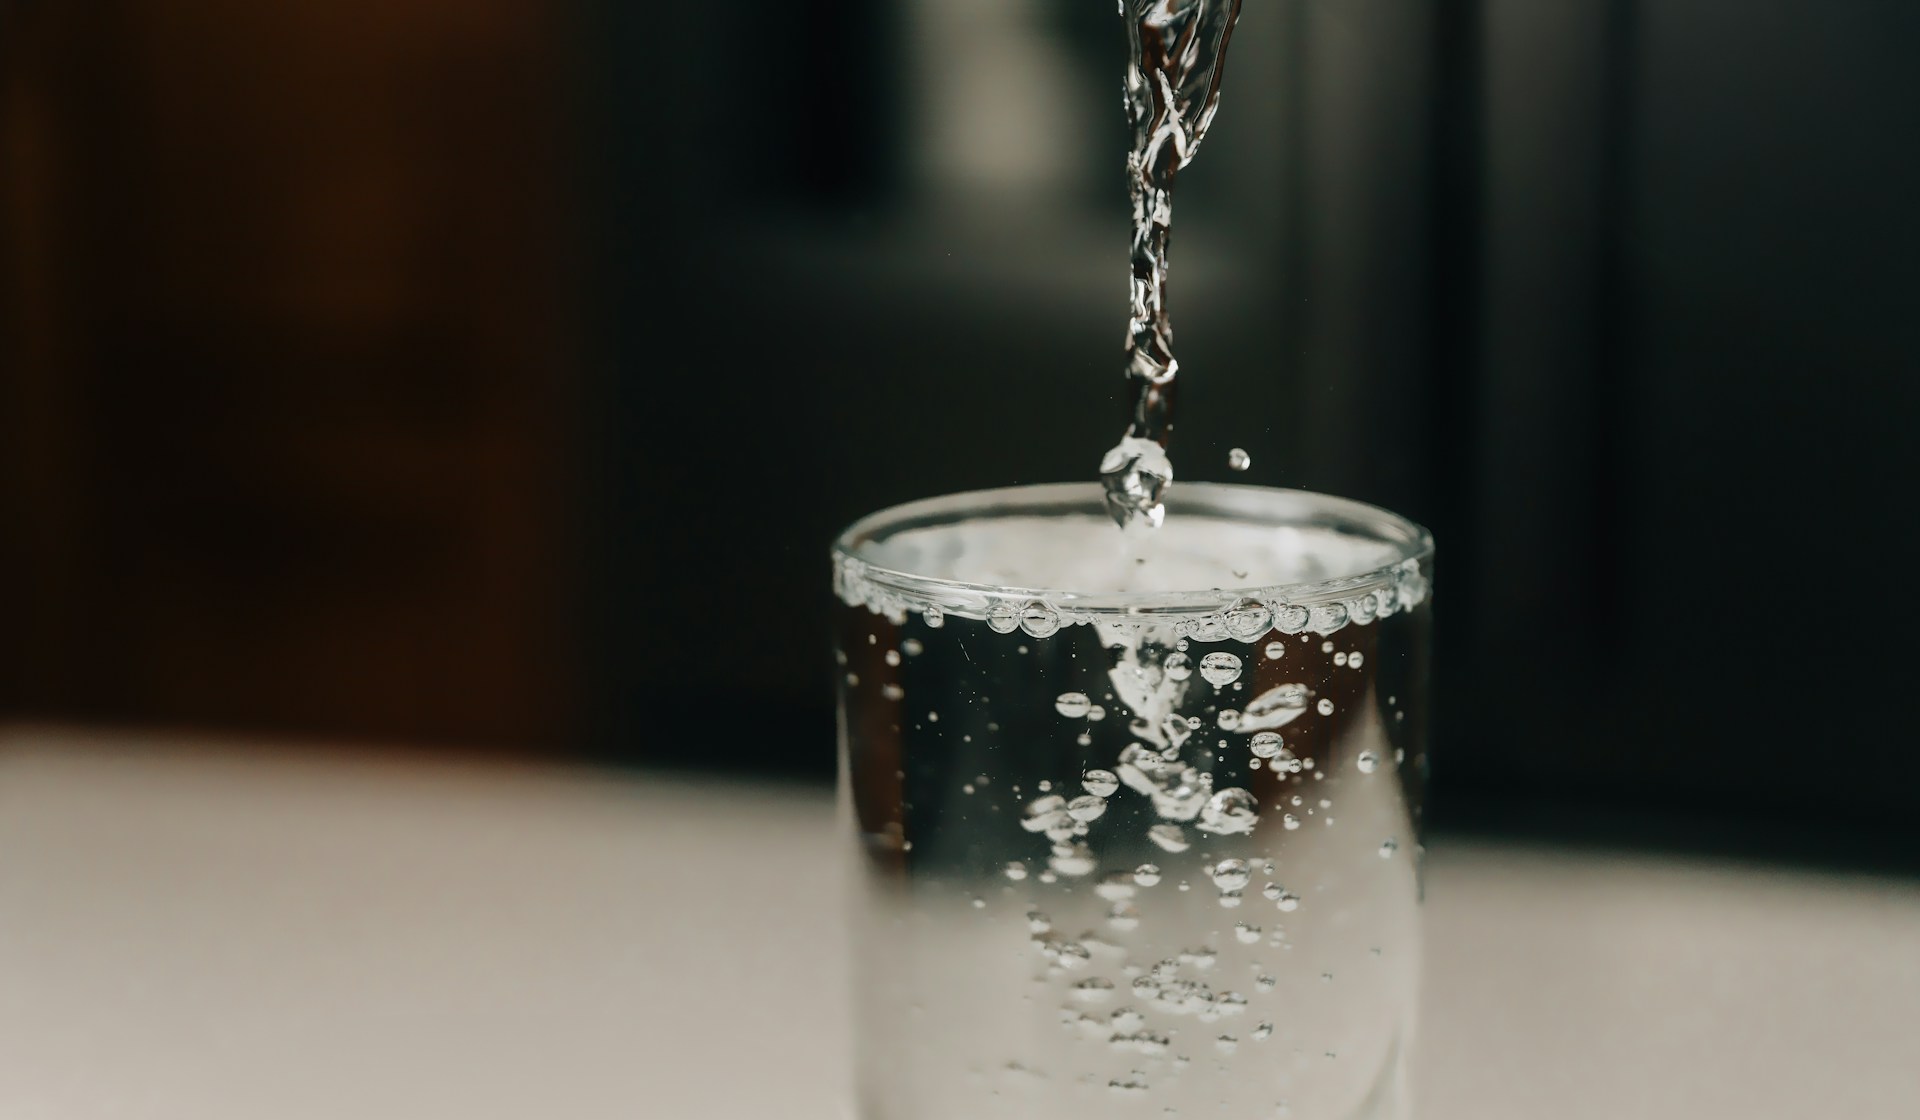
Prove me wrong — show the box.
[833,484,1432,1120]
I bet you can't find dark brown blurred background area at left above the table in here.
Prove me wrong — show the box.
[0,0,580,745]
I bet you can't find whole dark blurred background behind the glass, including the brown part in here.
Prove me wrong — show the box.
[0,0,1920,861]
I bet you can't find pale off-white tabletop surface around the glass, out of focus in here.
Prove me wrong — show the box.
[0,728,1920,1120]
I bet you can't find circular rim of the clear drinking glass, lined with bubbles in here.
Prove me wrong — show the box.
[833,482,1434,636]
